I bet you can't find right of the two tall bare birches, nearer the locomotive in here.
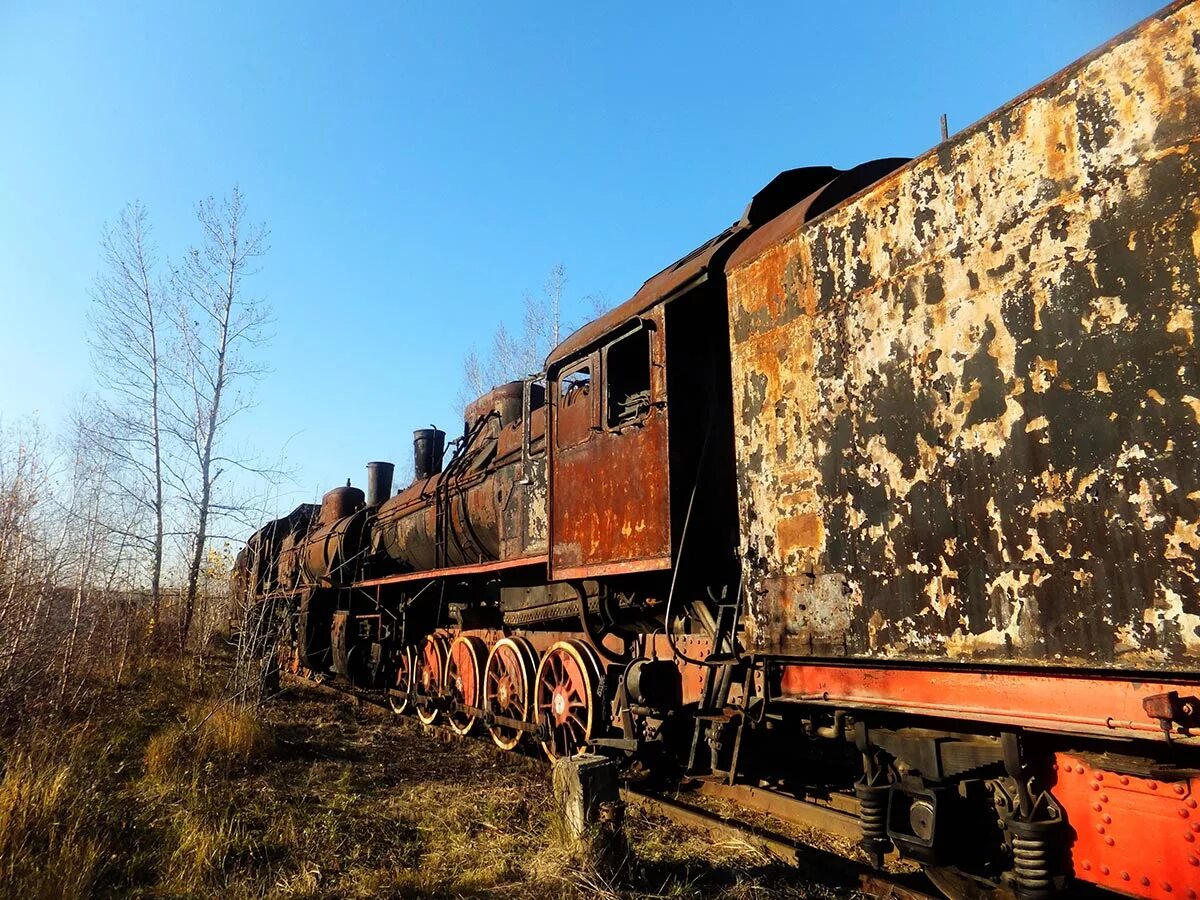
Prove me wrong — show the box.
[170,188,269,648]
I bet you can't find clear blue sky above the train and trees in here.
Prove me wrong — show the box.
[0,0,1159,518]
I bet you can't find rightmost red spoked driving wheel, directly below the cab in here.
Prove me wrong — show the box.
[534,641,601,760]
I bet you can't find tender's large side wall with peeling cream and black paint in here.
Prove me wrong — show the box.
[727,5,1200,667]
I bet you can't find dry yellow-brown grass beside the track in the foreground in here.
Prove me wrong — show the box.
[0,666,864,899]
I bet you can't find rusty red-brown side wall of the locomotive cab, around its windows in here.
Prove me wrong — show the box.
[550,306,671,578]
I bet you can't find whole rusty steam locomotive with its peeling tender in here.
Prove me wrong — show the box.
[234,2,1200,898]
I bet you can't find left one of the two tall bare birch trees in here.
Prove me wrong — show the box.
[82,204,174,622]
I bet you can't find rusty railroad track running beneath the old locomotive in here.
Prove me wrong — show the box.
[283,674,942,900]
